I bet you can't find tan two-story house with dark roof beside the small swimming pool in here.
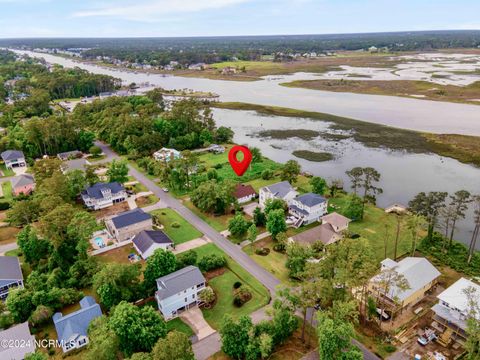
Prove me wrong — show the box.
[105,208,153,242]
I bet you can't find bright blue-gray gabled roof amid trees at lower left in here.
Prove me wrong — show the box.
[53,296,102,342]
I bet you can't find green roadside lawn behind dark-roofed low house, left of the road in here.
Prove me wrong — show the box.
[152,209,202,245]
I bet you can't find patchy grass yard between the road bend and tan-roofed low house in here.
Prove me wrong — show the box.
[243,237,294,286]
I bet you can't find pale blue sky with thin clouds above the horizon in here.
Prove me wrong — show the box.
[0,0,480,38]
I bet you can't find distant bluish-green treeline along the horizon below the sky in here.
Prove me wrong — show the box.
[0,30,480,65]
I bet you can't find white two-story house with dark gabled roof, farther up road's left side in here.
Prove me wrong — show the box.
[81,182,127,210]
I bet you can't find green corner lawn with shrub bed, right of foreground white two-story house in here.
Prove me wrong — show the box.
[190,244,270,329]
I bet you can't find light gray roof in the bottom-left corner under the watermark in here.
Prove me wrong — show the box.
[0,321,35,360]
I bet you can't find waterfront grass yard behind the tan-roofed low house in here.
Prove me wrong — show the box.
[329,195,412,261]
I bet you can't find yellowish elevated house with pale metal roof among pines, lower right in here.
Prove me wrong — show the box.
[368,257,441,316]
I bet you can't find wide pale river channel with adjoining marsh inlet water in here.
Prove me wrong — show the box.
[14,53,480,249]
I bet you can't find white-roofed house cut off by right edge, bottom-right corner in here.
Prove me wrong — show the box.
[432,278,480,346]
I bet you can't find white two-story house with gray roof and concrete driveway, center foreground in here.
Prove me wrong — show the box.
[155,266,206,320]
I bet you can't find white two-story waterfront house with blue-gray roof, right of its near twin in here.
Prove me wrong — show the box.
[288,193,328,227]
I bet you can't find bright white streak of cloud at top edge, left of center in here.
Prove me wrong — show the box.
[73,0,251,21]
